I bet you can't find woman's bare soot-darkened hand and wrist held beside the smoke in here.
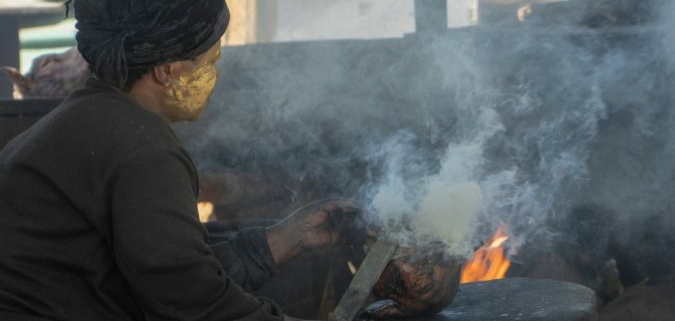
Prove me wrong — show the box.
[267,198,373,265]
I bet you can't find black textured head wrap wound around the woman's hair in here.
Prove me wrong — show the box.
[73,0,230,89]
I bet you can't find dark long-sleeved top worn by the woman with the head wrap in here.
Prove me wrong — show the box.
[0,80,282,321]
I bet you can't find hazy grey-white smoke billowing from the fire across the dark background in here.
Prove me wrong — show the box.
[180,1,675,273]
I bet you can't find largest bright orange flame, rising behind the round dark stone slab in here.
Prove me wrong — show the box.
[460,226,511,283]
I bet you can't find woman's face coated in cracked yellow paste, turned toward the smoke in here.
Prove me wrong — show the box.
[165,42,220,122]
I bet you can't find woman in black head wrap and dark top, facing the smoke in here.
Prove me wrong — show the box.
[0,0,365,321]
